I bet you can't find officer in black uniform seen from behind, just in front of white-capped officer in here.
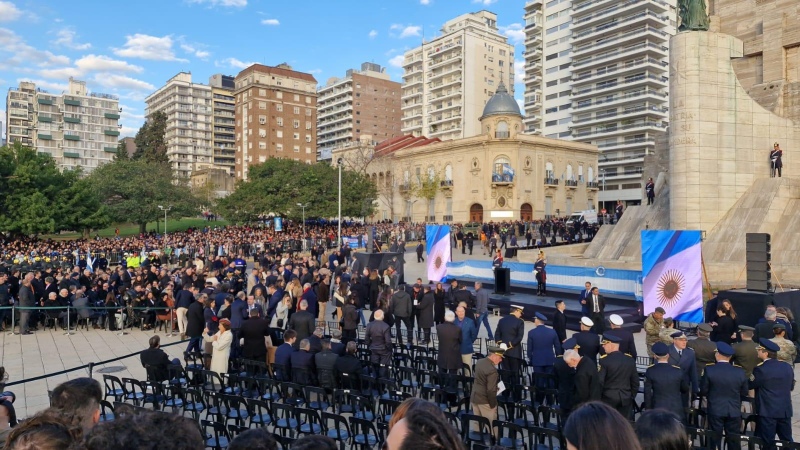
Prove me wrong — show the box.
[597,334,639,420]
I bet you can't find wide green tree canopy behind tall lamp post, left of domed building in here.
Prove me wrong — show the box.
[219,158,377,222]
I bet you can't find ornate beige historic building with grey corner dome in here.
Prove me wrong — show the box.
[360,84,599,223]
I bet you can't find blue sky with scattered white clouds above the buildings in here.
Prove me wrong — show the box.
[0,0,524,136]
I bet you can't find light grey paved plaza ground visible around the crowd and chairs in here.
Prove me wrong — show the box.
[0,246,800,438]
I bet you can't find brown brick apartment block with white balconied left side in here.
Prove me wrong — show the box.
[317,62,401,160]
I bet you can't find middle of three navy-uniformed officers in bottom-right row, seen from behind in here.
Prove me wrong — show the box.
[700,342,748,450]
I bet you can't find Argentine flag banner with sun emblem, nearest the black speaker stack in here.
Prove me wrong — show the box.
[642,230,703,323]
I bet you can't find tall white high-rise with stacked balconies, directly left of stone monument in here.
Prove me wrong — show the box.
[525,0,676,208]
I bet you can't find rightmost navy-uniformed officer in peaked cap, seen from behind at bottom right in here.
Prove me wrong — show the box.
[749,338,794,448]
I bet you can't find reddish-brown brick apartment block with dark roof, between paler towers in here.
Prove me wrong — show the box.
[234,64,317,180]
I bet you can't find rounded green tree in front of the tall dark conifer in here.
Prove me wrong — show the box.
[87,159,199,233]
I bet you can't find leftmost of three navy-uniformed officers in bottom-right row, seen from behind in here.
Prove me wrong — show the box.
[644,342,689,423]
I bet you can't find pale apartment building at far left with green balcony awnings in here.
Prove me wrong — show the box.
[6,78,121,173]
